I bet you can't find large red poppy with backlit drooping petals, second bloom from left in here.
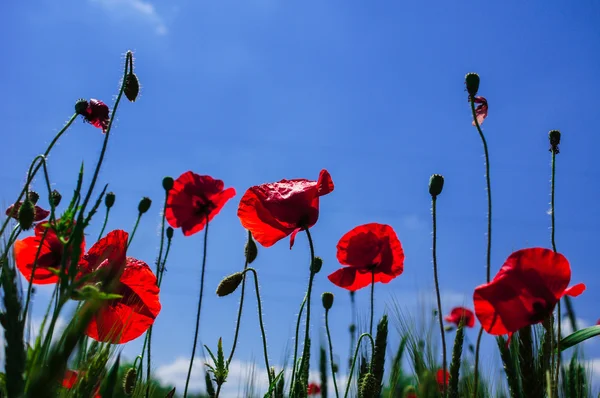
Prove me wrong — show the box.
[79,230,161,344]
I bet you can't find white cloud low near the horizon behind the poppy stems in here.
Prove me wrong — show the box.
[155,357,346,398]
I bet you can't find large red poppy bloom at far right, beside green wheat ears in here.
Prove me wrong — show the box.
[473,248,585,337]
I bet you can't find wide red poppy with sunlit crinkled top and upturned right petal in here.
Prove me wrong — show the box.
[238,170,333,249]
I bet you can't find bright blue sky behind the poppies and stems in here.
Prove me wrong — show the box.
[0,0,600,396]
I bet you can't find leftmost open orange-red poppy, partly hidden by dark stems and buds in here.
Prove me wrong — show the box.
[14,220,85,285]
